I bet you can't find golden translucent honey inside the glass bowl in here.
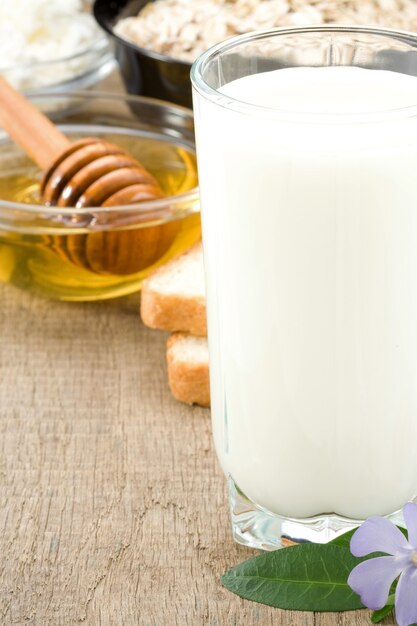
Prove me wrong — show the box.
[0,132,200,300]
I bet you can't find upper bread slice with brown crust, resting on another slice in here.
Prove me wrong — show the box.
[141,243,207,336]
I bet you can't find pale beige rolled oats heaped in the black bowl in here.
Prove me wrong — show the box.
[115,0,417,63]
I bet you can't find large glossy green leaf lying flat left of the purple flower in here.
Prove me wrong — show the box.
[221,543,363,611]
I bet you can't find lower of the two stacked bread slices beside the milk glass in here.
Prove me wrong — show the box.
[167,333,210,406]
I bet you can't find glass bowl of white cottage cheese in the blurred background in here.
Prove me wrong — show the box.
[0,0,115,93]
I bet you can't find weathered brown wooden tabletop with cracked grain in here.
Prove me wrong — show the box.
[0,286,393,626]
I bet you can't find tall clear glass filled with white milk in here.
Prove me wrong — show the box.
[192,26,417,549]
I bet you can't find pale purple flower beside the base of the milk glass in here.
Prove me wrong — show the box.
[348,502,417,626]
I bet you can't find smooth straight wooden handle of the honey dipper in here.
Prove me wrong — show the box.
[0,76,70,170]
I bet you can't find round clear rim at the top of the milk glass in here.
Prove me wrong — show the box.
[190,24,417,124]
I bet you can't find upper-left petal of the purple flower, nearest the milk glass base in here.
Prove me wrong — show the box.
[350,517,409,556]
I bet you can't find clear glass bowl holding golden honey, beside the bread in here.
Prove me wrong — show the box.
[0,92,200,300]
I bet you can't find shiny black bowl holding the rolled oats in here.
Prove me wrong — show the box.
[93,0,192,107]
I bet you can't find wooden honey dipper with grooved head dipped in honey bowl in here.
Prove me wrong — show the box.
[0,76,178,274]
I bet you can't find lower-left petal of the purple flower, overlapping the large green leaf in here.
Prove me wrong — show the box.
[348,556,402,610]
